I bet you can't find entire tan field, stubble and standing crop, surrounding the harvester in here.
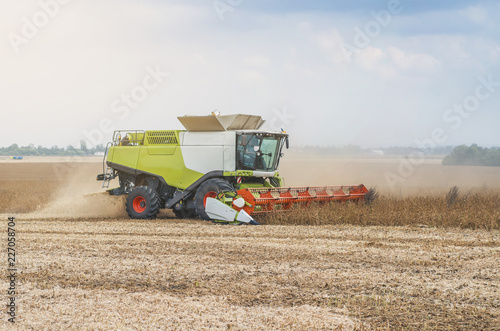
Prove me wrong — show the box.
[0,158,500,330]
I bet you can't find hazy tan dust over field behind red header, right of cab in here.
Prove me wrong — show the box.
[280,153,500,197]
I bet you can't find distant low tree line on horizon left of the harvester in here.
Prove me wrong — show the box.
[0,141,104,156]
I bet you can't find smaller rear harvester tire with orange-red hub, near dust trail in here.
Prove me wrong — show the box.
[125,186,161,220]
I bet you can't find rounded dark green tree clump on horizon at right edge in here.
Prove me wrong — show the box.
[443,144,500,167]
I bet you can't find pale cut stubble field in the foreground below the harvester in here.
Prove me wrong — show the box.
[2,218,500,330]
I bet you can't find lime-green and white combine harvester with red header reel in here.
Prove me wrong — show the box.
[97,114,368,224]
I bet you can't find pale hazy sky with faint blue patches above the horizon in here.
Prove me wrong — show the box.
[0,0,500,148]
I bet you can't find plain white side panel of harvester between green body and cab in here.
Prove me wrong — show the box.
[181,146,224,174]
